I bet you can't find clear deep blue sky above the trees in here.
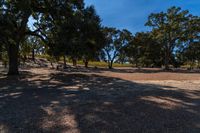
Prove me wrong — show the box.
[85,0,200,33]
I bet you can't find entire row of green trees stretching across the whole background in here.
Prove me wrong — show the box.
[0,0,200,75]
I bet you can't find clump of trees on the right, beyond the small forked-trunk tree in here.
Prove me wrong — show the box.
[113,7,200,70]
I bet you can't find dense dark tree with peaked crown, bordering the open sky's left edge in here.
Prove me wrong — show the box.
[51,6,104,67]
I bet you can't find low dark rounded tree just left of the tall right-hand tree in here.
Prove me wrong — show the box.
[125,32,162,67]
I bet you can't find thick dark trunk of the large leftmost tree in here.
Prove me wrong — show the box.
[8,44,19,75]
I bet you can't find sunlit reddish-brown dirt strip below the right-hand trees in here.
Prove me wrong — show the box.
[97,68,200,81]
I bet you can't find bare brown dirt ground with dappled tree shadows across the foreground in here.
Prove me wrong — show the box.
[0,68,200,133]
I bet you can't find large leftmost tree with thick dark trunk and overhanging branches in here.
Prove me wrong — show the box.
[0,0,83,75]
